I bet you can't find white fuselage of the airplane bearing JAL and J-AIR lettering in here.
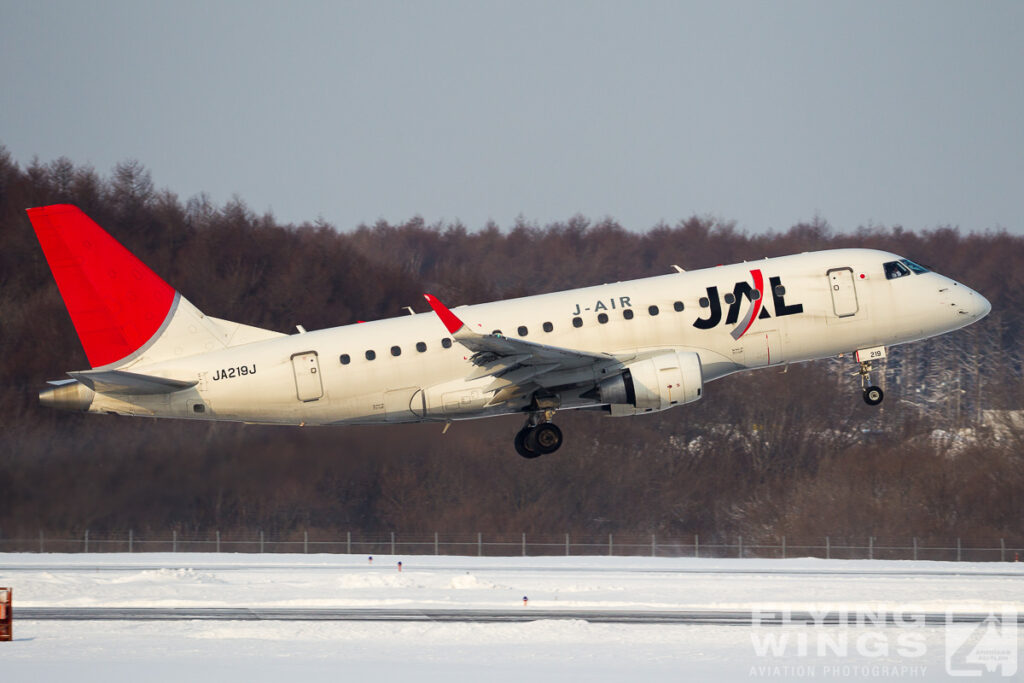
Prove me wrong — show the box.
[81,249,989,424]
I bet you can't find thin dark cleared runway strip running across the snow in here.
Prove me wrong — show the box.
[14,606,1024,627]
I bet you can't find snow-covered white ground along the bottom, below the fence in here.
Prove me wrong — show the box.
[0,554,1024,683]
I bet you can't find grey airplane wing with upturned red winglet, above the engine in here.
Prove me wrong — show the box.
[423,294,620,405]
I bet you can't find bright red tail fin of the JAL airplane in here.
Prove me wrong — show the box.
[28,204,175,368]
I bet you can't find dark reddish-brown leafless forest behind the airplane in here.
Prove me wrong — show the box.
[0,146,1024,545]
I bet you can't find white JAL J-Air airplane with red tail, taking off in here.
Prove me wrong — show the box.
[28,205,991,458]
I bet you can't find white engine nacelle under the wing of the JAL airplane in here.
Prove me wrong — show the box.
[597,351,703,417]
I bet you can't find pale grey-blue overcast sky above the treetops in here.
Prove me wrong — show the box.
[0,0,1024,233]
